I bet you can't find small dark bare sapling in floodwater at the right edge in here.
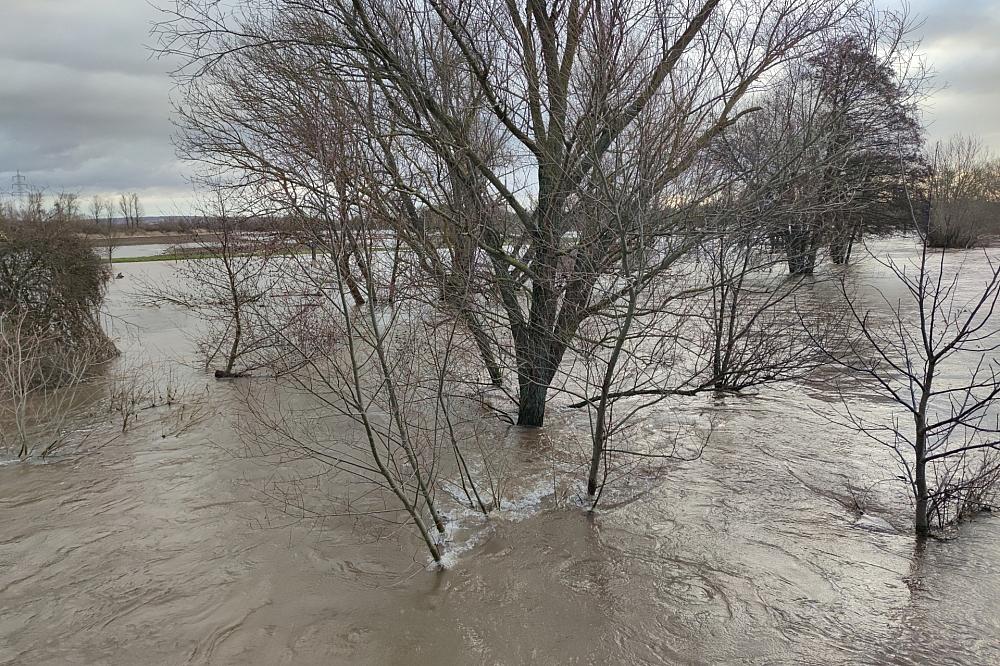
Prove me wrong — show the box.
[824,234,1000,535]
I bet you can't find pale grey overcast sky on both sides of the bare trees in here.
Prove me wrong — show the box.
[0,0,1000,215]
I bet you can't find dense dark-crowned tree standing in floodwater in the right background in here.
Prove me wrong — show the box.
[760,12,927,275]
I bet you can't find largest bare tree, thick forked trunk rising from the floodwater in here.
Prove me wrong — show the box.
[163,0,884,426]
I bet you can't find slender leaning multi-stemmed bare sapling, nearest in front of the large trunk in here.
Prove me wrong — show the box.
[236,210,503,564]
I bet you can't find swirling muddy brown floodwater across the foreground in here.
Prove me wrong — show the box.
[0,243,1000,664]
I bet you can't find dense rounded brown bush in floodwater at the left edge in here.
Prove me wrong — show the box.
[0,218,116,457]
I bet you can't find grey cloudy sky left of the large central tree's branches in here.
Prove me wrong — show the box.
[0,0,190,214]
